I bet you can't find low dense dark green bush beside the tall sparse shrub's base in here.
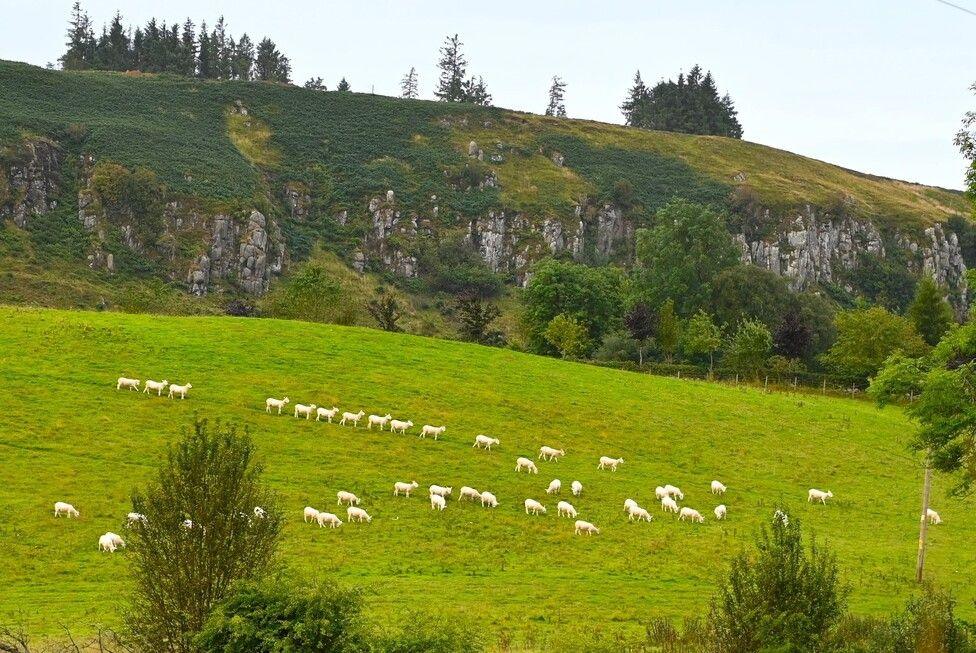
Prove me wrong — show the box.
[196,581,374,653]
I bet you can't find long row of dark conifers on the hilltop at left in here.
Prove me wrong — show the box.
[60,2,291,83]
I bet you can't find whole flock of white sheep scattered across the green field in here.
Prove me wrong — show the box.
[54,377,942,553]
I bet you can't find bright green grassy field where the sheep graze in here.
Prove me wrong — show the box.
[0,308,976,634]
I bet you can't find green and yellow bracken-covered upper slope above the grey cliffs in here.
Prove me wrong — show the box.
[0,62,968,225]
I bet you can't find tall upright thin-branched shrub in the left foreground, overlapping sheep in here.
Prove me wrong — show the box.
[126,420,282,652]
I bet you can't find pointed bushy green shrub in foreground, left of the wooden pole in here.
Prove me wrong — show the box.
[709,510,847,653]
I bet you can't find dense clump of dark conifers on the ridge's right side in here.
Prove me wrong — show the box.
[620,65,742,138]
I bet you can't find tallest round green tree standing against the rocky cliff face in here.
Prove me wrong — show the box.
[634,199,739,316]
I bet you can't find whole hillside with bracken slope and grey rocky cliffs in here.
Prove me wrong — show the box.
[0,57,968,312]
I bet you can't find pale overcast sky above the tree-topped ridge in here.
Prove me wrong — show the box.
[0,0,976,188]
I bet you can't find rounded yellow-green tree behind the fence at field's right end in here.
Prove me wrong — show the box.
[821,306,925,378]
